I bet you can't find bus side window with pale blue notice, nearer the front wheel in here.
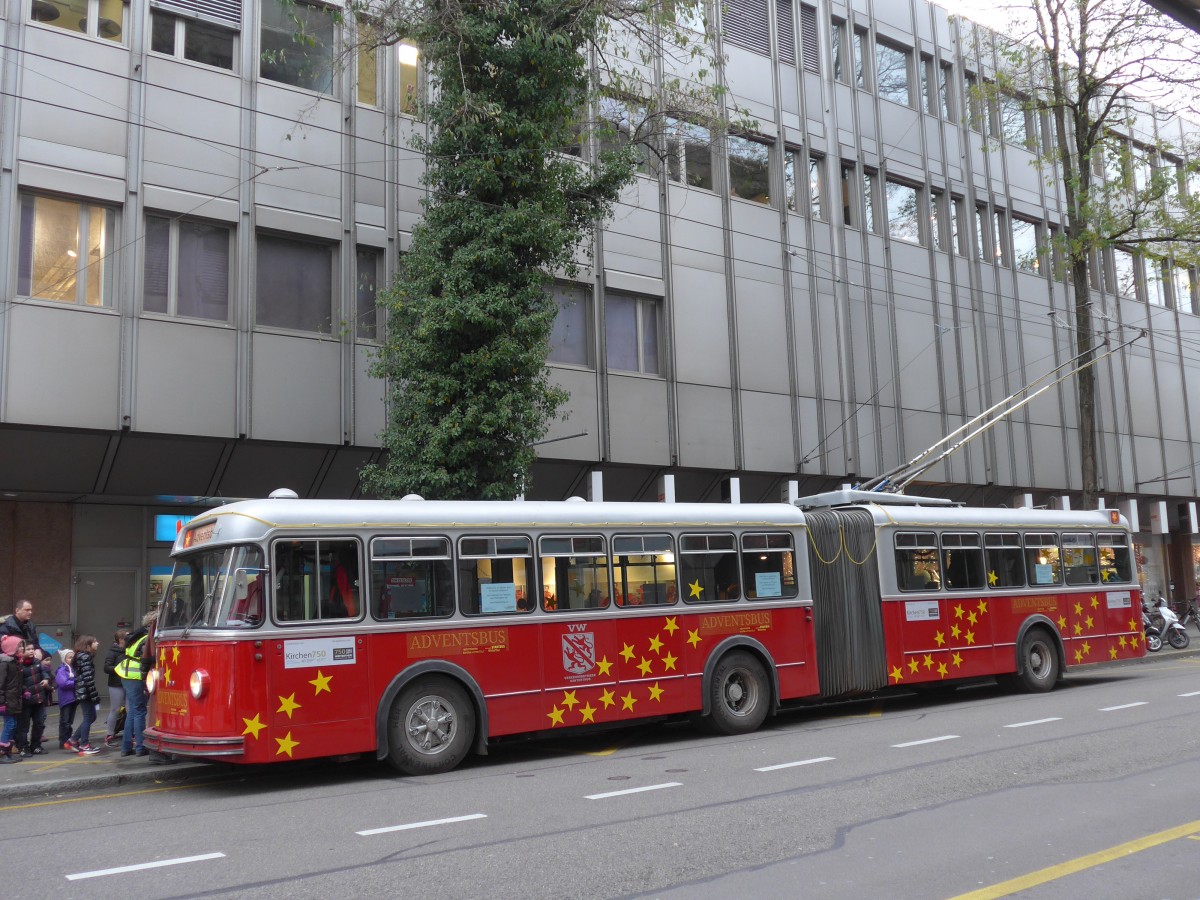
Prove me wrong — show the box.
[458,536,535,616]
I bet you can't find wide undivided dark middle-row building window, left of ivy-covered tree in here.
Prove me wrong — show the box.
[254,234,336,334]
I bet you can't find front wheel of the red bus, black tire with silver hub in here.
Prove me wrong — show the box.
[388,676,475,775]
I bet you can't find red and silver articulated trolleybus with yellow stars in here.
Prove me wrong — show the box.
[146,490,1144,774]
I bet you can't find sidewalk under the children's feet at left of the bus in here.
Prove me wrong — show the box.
[0,707,223,808]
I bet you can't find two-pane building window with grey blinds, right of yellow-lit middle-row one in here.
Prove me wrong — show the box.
[142,215,233,322]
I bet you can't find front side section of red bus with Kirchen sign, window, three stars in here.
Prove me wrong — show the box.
[266,538,374,758]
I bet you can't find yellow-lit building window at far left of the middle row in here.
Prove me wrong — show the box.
[17,194,116,306]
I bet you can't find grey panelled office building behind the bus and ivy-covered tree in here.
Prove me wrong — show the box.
[0,0,1200,638]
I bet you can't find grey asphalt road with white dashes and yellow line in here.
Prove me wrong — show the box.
[9,656,1200,900]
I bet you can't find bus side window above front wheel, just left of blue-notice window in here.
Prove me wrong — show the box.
[371,538,454,619]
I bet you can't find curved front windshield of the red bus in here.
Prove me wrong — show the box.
[158,547,266,630]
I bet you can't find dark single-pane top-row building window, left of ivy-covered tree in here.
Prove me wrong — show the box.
[258,0,335,94]
